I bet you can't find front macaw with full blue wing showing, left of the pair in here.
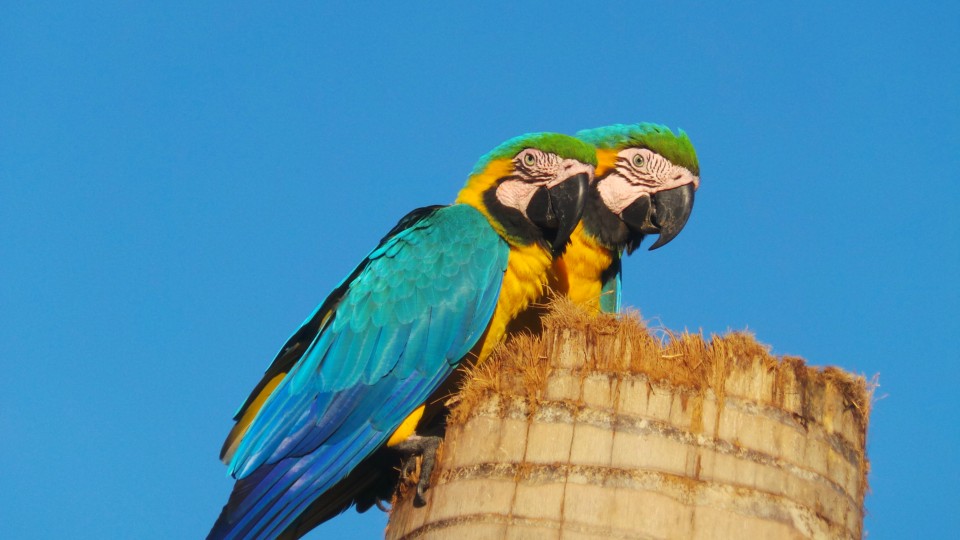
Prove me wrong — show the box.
[208,133,596,539]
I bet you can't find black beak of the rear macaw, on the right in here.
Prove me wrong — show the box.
[620,183,694,251]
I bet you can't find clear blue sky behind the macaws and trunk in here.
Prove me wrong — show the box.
[0,0,960,539]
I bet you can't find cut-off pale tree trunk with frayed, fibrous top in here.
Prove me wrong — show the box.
[386,305,870,540]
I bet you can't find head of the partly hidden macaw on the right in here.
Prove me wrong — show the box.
[577,123,700,253]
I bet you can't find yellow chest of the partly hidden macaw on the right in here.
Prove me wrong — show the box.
[550,224,613,311]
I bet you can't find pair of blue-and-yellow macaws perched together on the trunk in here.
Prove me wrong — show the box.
[208,123,700,539]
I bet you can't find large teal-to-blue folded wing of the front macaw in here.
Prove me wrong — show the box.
[210,205,509,538]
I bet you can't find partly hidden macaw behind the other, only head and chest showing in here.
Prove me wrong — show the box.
[552,123,700,314]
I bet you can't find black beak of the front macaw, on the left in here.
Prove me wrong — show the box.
[527,173,590,257]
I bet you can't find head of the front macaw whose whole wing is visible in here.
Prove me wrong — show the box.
[457,133,597,257]
